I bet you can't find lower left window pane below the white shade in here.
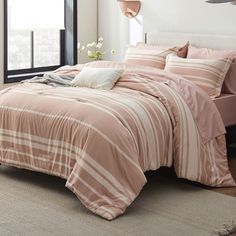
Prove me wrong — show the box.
[8,30,31,70]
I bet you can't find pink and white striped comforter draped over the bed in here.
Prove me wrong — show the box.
[0,62,235,220]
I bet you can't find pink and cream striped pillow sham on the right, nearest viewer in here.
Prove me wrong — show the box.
[165,55,231,98]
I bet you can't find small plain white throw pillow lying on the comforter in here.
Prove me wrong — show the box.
[71,67,124,90]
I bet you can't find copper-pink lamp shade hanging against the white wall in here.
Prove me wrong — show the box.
[117,0,141,18]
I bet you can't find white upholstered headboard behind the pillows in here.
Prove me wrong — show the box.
[145,32,236,50]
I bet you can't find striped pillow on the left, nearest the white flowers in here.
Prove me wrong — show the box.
[125,46,176,69]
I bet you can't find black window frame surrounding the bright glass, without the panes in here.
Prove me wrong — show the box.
[4,0,77,83]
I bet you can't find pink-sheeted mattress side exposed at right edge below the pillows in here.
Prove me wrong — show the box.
[214,94,236,127]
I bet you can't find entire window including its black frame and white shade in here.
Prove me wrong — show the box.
[4,0,77,83]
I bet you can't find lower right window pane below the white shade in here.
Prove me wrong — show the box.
[34,30,60,67]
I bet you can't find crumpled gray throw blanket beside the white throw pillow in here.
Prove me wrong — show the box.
[23,73,74,87]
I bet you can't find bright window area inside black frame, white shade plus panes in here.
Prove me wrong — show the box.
[7,0,64,70]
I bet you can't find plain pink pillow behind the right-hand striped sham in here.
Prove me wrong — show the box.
[187,46,236,94]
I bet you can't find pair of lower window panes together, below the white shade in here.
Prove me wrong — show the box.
[8,30,63,71]
